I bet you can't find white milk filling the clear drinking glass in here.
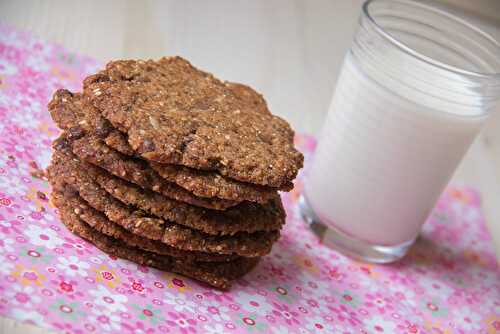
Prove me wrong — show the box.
[305,53,485,246]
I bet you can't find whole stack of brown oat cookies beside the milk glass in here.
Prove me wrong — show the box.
[48,57,303,289]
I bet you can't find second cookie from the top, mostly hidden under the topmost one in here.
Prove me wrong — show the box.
[49,89,293,203]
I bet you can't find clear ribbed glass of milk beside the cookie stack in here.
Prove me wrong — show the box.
[300,0,500,263]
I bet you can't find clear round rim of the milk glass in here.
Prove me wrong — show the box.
[362,0,500,80]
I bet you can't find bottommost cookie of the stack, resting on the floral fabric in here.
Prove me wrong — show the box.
[61,204,259,290]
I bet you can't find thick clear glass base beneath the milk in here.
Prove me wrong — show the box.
[299,195,415,263]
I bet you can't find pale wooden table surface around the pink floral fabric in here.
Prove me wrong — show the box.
[0,0,500,333]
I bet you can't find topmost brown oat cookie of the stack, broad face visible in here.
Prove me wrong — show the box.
[84,57,303,187]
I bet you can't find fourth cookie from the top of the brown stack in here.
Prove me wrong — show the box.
[49,135,285,235]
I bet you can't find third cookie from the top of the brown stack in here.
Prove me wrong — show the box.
[71,135,239,210]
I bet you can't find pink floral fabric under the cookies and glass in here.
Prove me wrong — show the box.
[0,26,500,334]
